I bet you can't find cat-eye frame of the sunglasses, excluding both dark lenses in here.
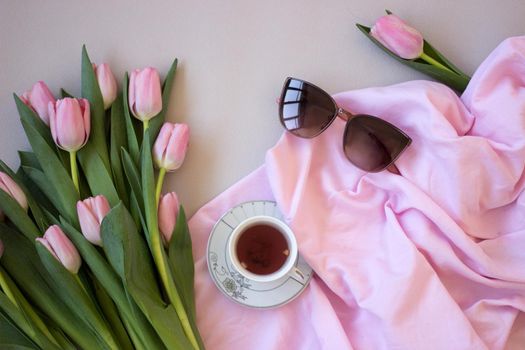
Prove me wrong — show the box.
[279,77,412,174]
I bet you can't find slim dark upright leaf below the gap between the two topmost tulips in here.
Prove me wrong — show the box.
[110,94,129,205]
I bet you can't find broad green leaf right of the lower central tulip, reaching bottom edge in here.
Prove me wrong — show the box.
[101,204,191,349]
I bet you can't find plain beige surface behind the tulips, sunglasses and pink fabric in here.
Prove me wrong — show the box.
[0,0,525,213]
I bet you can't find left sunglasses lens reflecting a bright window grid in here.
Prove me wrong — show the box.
[279,78,336,138]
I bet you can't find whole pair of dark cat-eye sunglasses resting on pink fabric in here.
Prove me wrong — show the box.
[279,78,412,173]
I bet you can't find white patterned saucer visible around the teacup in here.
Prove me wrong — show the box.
[206,200,313,308]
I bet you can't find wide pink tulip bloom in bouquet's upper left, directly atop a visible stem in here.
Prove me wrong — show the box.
[48,98,91,152]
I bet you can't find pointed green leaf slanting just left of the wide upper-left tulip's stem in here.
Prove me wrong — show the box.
[22,119,79,223]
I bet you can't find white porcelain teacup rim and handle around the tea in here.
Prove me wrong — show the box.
[228,215,306,283]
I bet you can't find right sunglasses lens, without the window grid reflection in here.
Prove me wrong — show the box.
[343,115,411,172]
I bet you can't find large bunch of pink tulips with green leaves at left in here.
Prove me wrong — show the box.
[0,47,203,350]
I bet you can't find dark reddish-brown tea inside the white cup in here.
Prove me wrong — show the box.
[236,225,290,275]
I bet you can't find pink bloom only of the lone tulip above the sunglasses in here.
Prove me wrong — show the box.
[370,15,423,60]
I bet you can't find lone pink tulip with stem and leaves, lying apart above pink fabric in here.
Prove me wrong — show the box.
[356,11,470,92]
